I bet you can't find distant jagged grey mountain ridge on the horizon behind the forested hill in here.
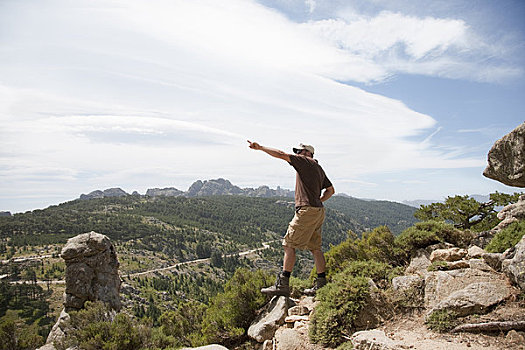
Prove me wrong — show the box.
[80,178,294,200]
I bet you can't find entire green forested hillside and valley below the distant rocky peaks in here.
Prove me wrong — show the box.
[0,195,415,346]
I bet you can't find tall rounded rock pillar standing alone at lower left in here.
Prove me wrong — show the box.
[41,232,121,350]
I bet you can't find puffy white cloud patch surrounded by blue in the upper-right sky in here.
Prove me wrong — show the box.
[303,12,523,82]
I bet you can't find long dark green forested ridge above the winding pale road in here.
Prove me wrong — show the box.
[0,196,415,253]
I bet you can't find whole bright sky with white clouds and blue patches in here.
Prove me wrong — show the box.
[0,0,525,212]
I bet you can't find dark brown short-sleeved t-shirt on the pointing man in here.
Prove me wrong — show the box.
[290,154,332,207]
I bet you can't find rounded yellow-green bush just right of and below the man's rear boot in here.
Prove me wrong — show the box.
[310,270,370,347]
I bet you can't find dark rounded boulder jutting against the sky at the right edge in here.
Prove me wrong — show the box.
[483,123,525,187]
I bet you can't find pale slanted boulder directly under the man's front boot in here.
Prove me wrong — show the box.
[248,296,294,343]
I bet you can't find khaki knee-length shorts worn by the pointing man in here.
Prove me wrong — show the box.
[283,207,325,250]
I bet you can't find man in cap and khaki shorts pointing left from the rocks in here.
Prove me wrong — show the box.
[248,141,335,297]
